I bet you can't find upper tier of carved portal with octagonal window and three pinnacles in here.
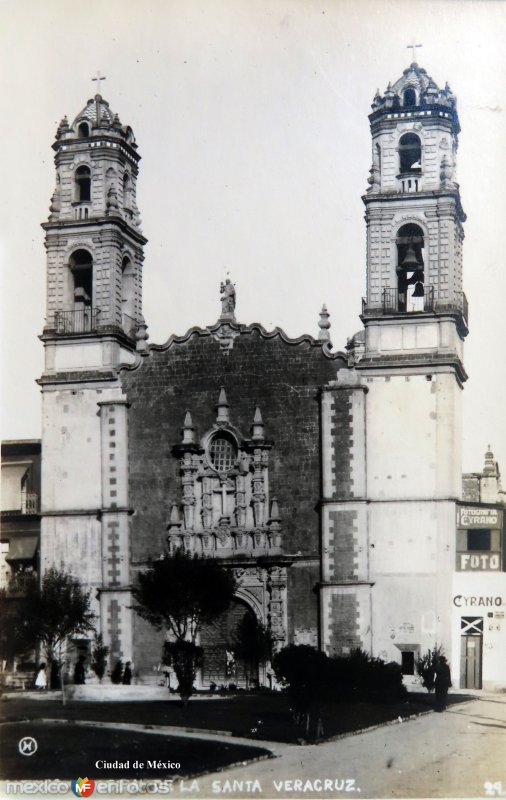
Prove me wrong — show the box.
[168,389,281,557]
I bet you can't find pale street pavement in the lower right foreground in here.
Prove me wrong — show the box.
[179,695,506,800]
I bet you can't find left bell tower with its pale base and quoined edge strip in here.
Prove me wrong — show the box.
[39,94,147,658]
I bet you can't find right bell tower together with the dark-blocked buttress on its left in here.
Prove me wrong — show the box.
[322,63,468,674]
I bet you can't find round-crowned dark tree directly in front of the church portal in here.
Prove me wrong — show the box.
[132,550,237,702]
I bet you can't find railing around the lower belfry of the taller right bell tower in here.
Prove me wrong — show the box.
[362,286,468,325]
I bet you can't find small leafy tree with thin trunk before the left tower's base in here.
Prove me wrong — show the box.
[26,567,95,703]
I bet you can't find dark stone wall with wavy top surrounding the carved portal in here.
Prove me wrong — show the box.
[122,330,340,562]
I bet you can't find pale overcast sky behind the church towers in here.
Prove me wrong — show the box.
[0,0,506,482]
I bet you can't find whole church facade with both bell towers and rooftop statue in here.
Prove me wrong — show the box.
[39,64,506,686]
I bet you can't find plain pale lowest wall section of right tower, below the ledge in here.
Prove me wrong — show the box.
[369,500,456,680]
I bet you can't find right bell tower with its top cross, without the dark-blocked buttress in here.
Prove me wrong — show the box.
[356,59,468,660]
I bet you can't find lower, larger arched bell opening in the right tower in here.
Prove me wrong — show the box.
[396,223,425,311]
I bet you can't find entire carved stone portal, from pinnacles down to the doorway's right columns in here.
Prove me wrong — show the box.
[167,388,287,646]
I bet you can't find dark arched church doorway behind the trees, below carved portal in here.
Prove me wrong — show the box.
[200,598,258,687]
